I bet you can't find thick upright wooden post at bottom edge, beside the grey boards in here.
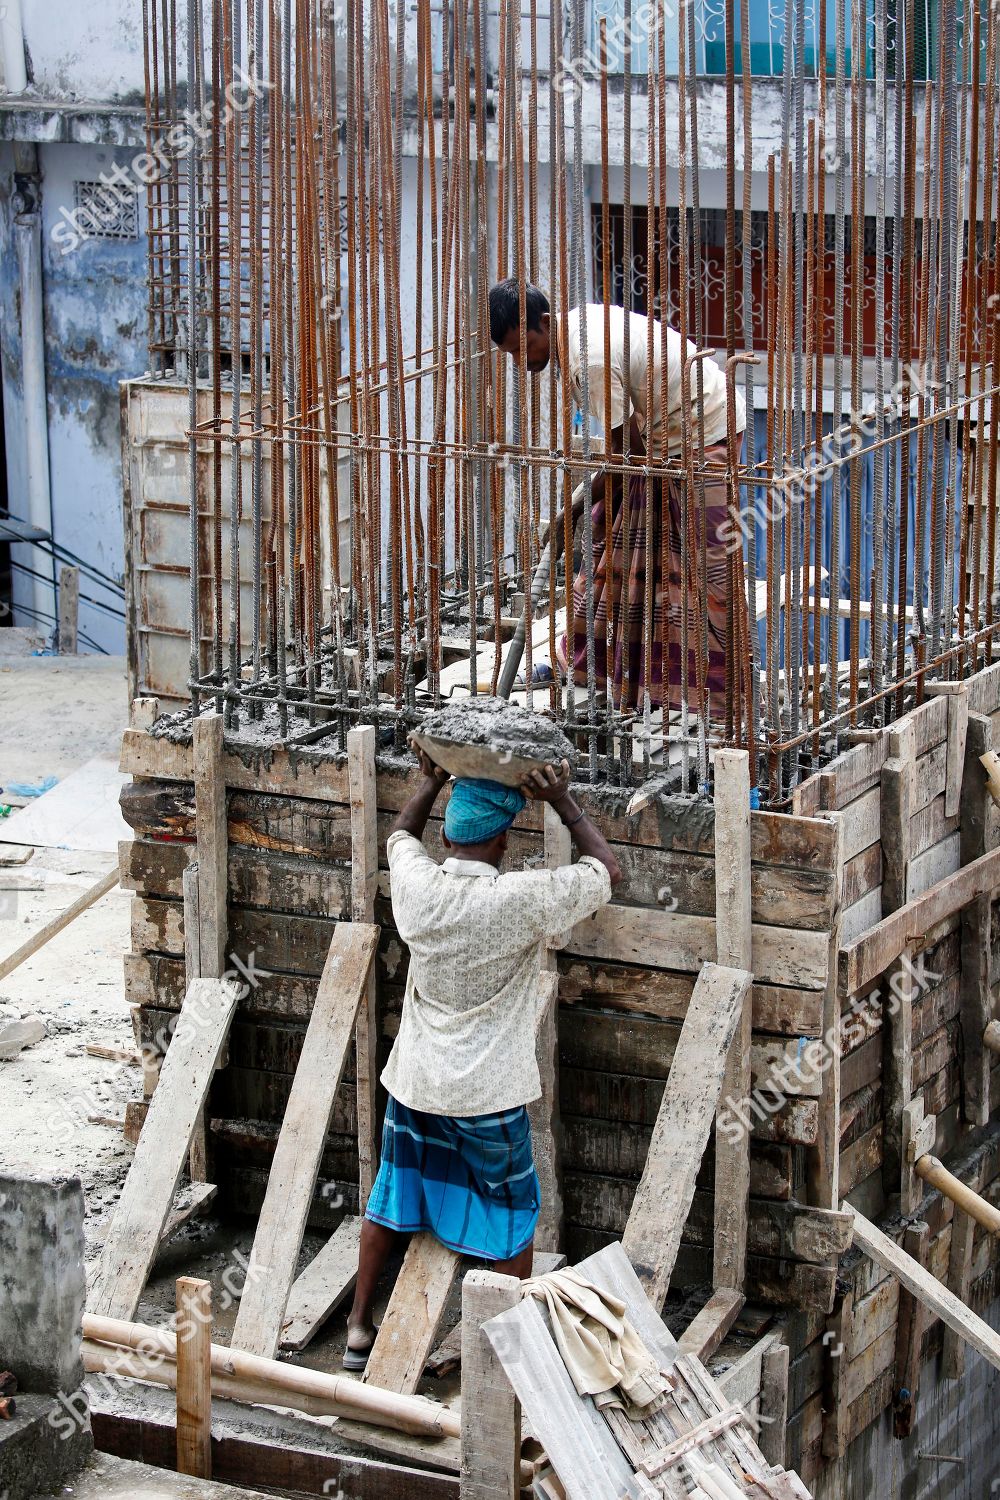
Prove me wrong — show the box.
[460,1271,520,1500]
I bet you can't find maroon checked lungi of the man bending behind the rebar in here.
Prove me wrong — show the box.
[573,440,745,714]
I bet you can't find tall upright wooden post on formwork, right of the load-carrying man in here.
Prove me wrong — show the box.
[712,750,753,1292]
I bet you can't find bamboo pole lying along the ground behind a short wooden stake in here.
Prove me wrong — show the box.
[84,1313,460,1437]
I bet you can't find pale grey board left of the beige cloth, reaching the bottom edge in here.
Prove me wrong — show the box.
[483,1298,642,1500]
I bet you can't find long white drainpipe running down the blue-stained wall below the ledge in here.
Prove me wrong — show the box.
[12,202,55,615]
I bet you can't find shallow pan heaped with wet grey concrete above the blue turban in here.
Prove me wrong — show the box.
[414,698,576,786]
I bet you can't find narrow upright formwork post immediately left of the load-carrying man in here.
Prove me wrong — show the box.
[348,725,378,1214]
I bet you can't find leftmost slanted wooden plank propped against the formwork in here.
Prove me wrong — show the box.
[88,980,240,1319]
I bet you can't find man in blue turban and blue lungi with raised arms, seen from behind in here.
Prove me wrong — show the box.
[343,741,621,1370]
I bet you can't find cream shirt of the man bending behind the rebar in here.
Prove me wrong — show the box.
[567,302,747,459]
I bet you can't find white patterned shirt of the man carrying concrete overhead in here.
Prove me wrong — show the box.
[382,833,612,1118]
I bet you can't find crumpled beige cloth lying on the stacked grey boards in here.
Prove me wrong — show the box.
[522,1268,672,1421]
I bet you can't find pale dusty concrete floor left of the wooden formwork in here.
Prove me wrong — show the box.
[0,651,141,1253]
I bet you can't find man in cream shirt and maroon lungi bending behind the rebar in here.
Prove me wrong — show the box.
[490,278,748,717]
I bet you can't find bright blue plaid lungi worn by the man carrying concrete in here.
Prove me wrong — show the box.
[366,1094,541,1260]
